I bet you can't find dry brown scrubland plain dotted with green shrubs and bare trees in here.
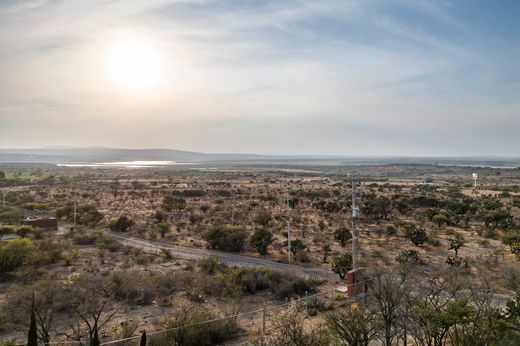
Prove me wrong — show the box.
[0,166,520,345]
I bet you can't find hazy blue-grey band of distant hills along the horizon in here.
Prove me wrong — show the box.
[0,146,520,167]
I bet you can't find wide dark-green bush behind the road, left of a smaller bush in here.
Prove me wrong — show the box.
[202,226,247,252]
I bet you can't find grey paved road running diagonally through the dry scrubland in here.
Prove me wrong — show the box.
[105,231,338,281]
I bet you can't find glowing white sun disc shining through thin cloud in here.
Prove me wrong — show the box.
[106,37,162,92]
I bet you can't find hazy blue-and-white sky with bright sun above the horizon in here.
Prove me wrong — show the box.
[0,0,520,156]
